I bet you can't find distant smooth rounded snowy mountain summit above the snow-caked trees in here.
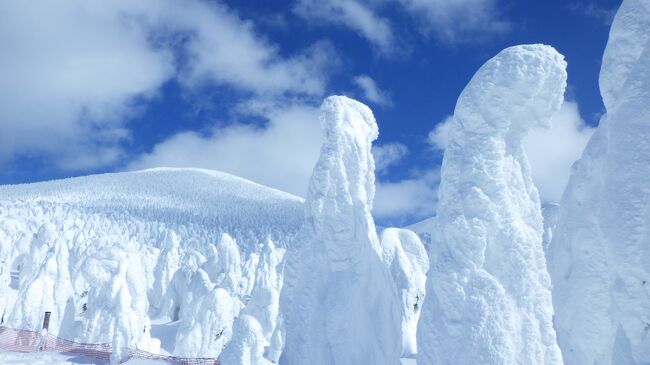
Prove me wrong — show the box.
[0,168,303,239]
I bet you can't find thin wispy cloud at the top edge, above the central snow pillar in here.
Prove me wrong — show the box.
[295,0,394,52]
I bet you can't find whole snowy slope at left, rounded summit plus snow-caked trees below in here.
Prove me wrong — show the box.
[0,169,304,361]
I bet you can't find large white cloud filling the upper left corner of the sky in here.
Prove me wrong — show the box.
[0,0,333,170]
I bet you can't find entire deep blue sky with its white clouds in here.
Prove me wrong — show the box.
[0,0,620,224]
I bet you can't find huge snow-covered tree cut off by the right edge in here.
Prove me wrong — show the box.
[549,0,650,365]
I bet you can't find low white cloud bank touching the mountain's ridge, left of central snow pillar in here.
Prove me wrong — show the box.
[129,105,322,196]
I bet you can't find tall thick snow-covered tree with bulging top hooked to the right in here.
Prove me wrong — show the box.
[418,45,567,364]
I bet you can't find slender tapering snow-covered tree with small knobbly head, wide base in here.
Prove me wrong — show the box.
[280,96,402,365]
